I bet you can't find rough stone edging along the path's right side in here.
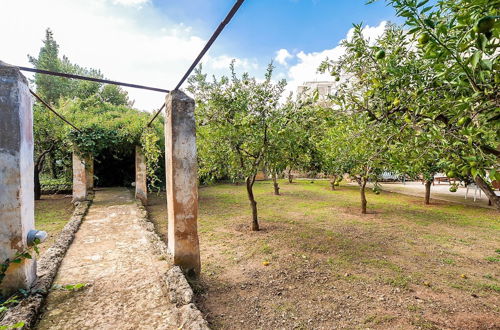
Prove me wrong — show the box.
[136,200,210,330]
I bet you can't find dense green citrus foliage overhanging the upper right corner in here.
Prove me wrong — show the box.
[364,0,500,191]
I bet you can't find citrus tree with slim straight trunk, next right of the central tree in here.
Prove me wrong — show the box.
[320,25,410,213]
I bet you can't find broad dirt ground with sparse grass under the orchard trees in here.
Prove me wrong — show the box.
[149,180,500,329]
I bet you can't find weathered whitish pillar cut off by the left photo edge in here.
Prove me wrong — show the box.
[0,62,36,296]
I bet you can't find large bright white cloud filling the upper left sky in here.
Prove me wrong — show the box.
[0,0,250,111]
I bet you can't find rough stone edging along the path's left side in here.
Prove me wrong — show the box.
[0,200,92,329]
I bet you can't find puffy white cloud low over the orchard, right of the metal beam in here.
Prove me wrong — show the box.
[280,21,387,93]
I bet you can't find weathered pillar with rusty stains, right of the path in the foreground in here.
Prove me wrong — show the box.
[165,91,201,277]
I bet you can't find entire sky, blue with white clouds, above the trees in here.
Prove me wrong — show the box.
[0,0,399,111]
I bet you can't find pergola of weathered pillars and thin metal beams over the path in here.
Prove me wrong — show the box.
[0,0,244,295]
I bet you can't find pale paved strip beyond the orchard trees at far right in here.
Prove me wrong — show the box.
[381,182,493,208]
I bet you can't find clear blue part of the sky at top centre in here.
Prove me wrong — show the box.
[153,0,396,65]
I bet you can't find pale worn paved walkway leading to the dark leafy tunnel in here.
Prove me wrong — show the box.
[38,188,179,329]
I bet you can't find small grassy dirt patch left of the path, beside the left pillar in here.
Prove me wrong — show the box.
[35,194,74,253]
